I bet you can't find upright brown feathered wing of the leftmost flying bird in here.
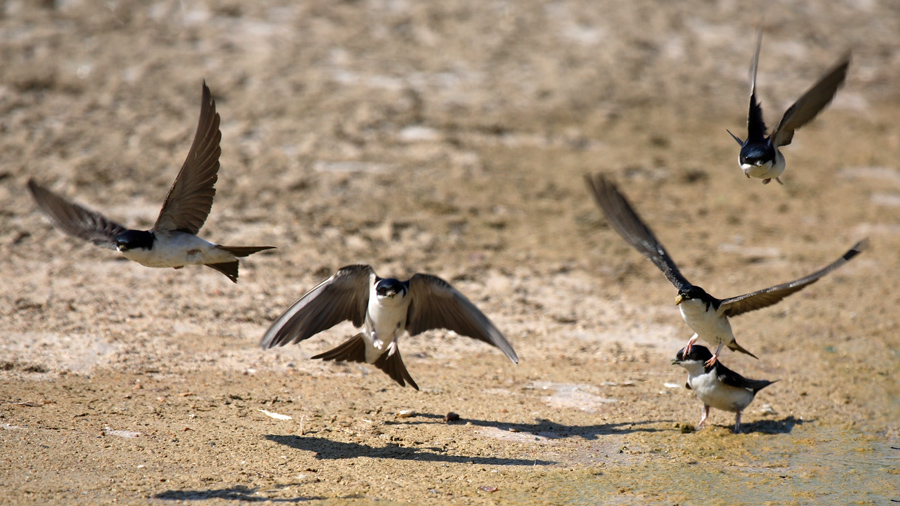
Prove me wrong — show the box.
[153,81,222,234]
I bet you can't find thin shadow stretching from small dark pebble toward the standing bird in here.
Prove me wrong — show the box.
[385,413,673,439]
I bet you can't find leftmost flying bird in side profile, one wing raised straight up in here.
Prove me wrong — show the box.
[28,82,274,283]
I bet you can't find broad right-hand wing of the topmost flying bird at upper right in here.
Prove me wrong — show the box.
[772,51,850,146]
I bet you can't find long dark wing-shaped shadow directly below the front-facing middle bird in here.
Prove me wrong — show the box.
[264,434,556,466]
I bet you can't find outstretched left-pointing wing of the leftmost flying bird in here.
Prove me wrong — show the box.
[28,179,128,250]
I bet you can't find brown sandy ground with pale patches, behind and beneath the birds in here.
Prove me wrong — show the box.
[0,0,900,504]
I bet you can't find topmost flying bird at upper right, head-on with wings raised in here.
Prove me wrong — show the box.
[726,28,850,184]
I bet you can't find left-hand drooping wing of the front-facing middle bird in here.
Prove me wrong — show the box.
[259,265,375,348]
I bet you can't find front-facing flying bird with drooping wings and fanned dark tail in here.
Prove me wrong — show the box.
[260,265,519,390]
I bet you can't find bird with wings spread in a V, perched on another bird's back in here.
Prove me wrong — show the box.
[585,174,868,365]
